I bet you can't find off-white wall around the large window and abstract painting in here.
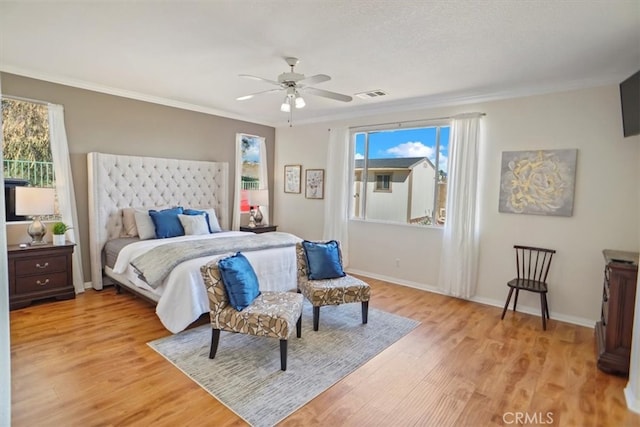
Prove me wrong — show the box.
[274,85,640,326]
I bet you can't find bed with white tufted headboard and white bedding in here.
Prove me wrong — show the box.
[87,153,300,333]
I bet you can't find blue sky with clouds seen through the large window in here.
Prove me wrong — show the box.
[355,127,449,172]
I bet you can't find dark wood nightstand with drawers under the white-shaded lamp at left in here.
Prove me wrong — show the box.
[7,242,76,310]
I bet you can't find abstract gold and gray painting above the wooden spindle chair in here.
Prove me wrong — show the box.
[498,149,578,216]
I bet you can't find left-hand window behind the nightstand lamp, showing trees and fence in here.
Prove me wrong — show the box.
[2,98,59,221]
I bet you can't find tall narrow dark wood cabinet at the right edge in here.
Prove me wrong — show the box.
[595,249,638,375]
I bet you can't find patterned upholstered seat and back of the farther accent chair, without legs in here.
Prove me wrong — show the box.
[296,243,371,307]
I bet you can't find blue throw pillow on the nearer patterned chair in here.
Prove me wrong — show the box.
[218,252,260,311]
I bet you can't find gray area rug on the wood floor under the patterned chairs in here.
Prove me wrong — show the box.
[149,301,420,426]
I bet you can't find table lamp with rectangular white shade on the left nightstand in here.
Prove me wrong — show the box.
[16,187,56,245]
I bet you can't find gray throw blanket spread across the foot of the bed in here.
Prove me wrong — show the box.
[131,232,302,289]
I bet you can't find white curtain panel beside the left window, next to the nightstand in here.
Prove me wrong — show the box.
[47,104,84,293]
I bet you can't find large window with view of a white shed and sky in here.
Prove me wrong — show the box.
[351,122,449,225]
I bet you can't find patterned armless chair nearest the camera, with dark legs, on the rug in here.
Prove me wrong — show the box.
[200,261,302,371]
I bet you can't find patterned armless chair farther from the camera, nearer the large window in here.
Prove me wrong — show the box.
[296,240,371,331]
